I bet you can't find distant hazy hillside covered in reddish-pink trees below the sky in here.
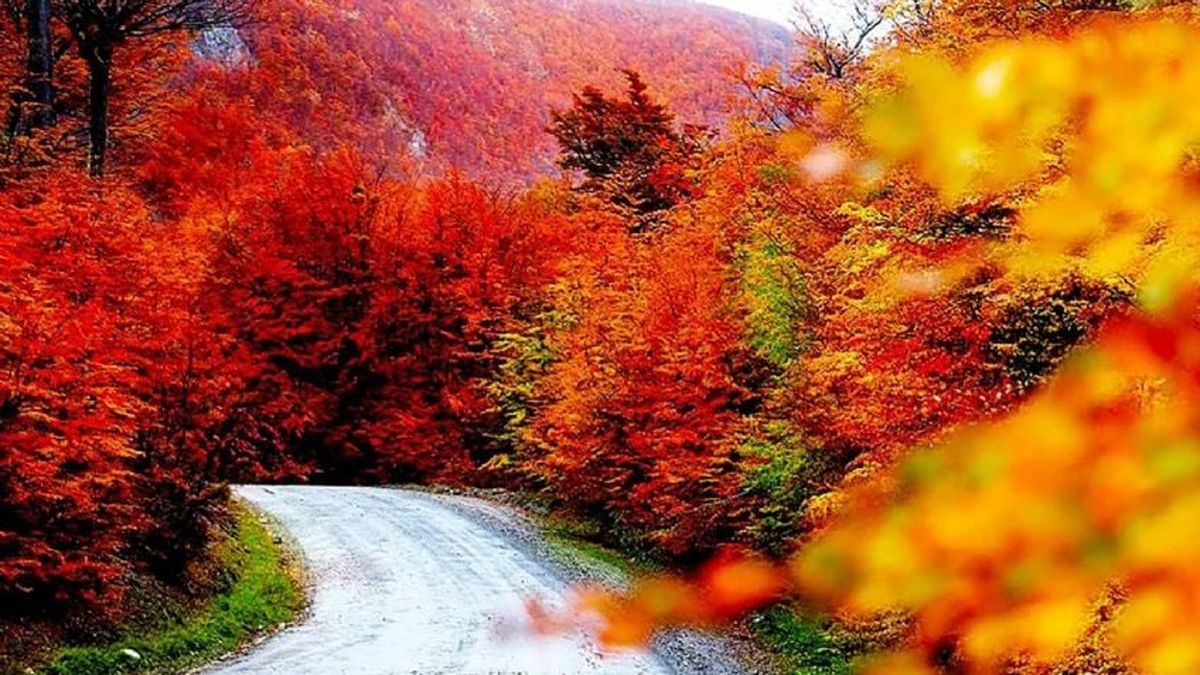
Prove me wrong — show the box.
[220,0,791,178]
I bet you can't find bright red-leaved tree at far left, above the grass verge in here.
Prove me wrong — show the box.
[0,174,220,614]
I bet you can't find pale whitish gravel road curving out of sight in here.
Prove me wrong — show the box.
[204,486,727,675]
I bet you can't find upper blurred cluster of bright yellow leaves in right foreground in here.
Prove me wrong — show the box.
[864,19,1200,305]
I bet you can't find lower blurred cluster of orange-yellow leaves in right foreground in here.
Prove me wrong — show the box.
[794,303,1200,674]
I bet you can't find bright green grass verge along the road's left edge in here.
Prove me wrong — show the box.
[34,502,305,675]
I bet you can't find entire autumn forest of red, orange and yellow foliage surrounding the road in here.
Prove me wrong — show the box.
[0,0,1200,675]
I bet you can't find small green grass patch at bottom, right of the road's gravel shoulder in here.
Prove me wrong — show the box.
[750,605,853,675]
